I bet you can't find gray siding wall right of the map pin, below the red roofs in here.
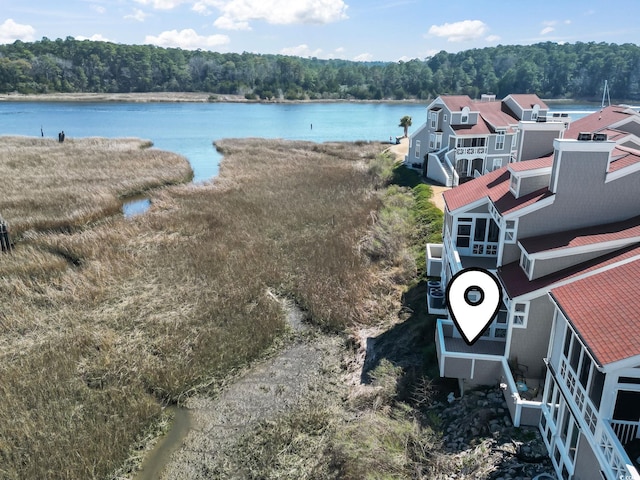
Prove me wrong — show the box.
[509,294,553,379]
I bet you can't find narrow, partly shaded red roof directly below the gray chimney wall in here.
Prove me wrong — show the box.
[519,216,640,253]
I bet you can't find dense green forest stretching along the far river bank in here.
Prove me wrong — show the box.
[0,37,640,101]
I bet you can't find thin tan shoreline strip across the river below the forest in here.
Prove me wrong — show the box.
[0,92,424,104]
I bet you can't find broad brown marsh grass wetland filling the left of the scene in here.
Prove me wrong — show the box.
[0,134,438,478]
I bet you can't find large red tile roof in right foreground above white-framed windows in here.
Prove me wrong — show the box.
[551,260,640,365]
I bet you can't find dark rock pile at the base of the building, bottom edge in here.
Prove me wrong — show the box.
[430,389,555,480]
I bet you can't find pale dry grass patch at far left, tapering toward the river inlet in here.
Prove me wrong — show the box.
[0,137,193,236]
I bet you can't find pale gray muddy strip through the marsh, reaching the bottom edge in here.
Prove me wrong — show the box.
[149,303,344,480]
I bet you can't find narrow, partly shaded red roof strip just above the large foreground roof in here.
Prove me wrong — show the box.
[497,244,640,298]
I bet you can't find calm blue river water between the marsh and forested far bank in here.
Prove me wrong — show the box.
[0,102,597,182]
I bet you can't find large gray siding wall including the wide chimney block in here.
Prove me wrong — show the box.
[518,151,640,238]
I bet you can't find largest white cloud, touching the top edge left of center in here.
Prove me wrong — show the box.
[212,0,348,25]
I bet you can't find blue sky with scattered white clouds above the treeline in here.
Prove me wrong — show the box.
[0,0,640,61]
